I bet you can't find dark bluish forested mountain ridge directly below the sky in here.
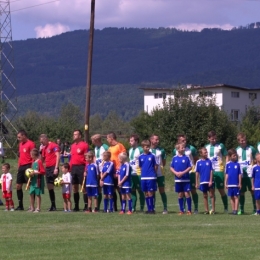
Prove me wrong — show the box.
[14,23,260,96]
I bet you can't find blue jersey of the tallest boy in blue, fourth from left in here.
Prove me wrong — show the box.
[139,152,157,180]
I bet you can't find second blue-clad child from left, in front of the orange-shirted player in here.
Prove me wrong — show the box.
[100,151,115,212]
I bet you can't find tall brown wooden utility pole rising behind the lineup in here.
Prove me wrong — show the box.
[85,0,95,143]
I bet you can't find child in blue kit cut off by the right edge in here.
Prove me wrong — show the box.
[252,153,260,215]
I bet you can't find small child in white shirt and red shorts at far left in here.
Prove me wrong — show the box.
[1,163,14,211]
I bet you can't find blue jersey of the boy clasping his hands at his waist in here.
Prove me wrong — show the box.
[171,155,191,182]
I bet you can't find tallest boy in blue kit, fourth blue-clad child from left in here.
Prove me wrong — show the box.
[138,140,158,214]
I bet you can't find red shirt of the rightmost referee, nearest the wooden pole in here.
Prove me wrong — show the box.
[70,141,89,165]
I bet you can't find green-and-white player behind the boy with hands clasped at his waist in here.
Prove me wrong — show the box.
[173,134,199,214]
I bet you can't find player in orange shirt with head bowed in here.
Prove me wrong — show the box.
[107,132,126,211]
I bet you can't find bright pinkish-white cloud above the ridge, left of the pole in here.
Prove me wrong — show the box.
[34,23,70,38]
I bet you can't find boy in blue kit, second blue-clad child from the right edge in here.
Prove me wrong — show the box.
[225,149,242,215]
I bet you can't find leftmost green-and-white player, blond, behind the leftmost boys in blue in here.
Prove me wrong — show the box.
[91,134,109,210]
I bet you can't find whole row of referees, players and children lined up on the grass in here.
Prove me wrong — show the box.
[1,130,260,214]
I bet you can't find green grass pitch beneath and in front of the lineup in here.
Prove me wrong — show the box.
[0,157,260,260]
